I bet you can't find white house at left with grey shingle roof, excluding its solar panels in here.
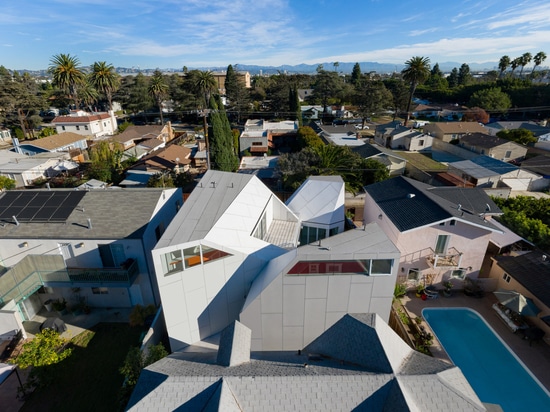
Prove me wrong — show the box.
[0,189,182,320]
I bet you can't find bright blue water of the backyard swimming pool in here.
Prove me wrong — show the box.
[422,308,550,412]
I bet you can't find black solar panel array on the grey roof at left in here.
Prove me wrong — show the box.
[0,191,86,223]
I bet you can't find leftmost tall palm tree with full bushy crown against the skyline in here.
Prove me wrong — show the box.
[48,53,86,109]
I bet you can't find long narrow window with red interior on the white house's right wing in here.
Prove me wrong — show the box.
[287,259,393,276]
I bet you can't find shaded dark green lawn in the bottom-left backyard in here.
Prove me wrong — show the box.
[21,323,142,412]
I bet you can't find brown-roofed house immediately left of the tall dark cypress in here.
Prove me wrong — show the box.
[130,143,191,173]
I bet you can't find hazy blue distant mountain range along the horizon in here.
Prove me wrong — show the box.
[18,62,498,76]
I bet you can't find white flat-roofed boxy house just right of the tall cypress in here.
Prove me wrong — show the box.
[239,119,299,155]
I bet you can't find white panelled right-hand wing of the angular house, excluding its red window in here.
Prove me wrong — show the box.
[240,223,399,351]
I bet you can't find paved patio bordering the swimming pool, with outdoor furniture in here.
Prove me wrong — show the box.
[401,291,550,390]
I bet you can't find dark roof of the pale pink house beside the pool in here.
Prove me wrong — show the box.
[365,176,501,232]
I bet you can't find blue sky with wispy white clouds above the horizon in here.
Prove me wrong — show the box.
[0,0,550,70]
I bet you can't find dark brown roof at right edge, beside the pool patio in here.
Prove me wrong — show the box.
[495,251,550,307]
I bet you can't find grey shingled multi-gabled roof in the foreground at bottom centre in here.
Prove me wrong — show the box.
[126,316,487,412]
